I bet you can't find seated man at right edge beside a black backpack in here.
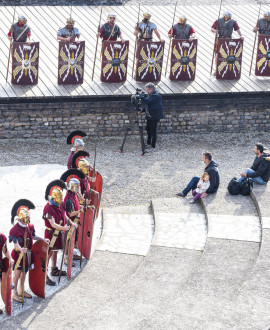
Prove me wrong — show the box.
[238,143,270,184]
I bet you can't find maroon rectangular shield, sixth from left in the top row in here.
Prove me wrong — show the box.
[216,39,243,80]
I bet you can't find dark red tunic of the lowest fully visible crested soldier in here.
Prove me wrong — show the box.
[9,222,35,270]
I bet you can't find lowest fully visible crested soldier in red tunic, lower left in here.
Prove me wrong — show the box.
[9,199,48,303]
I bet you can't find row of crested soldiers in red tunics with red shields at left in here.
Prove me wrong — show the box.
[0,131,102,315]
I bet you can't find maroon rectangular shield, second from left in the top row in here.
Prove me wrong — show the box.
[58,41,85,85]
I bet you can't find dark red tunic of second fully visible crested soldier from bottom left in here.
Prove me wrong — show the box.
[42,202,66,249]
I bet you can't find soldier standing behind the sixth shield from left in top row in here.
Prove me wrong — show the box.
[211,11,244,76]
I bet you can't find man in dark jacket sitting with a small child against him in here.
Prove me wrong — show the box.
[175,151,220,198]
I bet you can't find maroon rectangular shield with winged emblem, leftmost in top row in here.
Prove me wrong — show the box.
[11,42,39,85]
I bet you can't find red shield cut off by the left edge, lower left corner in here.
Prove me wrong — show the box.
[1,258,12,315]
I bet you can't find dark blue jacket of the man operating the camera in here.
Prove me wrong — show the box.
[144,90,164,120]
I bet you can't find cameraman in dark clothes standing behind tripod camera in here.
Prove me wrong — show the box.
[141,83,164,151]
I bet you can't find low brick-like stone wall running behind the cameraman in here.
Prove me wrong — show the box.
[0,94,270,138]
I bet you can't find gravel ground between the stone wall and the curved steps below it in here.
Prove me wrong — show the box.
[0,132,270,207]
